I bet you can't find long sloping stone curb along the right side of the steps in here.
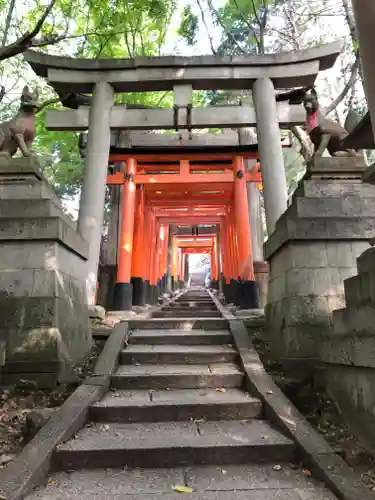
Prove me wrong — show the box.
[229,319,374,500]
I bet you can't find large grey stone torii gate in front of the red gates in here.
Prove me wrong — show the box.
[25,42,342,305]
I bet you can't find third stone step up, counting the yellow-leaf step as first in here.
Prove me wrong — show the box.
[90,389,262,423]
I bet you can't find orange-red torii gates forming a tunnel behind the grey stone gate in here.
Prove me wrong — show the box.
[107,152,261,310]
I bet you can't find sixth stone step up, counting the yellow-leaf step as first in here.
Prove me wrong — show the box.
[129,329,233,345]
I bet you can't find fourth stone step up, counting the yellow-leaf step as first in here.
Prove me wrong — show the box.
[112,363,244,389]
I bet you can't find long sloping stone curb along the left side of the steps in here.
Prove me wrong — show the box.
[0,322,128,500]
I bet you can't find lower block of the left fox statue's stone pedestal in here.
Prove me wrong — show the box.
[0,270,92,387]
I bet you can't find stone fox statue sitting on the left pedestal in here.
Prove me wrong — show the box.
[0,86,39,156]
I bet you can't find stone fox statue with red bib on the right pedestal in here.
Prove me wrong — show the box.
[276,87,359,156]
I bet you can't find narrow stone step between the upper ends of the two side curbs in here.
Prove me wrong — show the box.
[128,317,229,331]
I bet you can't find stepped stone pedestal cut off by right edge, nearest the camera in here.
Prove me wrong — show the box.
[320,162,375,453]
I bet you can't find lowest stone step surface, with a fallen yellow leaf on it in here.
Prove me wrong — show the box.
[26,465,333,500]
